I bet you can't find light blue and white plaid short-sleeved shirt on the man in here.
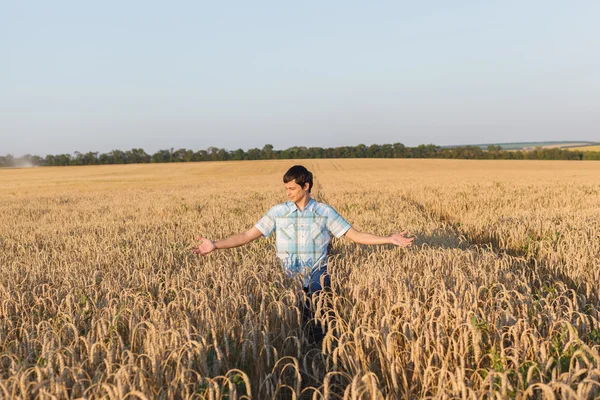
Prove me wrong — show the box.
[255,199,351,280]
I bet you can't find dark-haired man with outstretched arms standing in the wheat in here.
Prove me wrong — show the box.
[194,165,414,341]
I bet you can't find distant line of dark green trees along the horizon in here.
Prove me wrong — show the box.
[0,143,600,167]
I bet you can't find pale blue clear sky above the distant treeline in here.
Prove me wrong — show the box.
[0,0,600,155]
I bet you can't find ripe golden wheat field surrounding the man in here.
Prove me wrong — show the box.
[0,160,600,399]
